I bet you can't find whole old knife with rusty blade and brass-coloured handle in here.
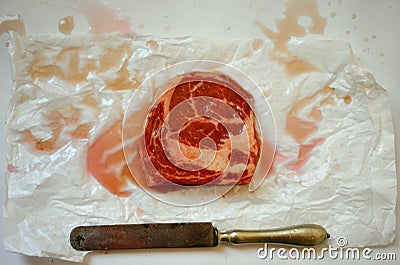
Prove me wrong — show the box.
[70,222,329,251]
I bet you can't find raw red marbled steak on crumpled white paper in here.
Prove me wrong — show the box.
[139,72,260,186]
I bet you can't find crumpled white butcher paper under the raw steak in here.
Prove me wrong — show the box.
[4,34,397,261]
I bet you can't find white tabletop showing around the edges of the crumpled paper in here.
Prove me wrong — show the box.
[0,0,400,264]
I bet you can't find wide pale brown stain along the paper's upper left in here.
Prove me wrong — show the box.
[29,45,143,90]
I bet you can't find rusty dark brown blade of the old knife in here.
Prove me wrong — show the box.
[70,223,218,251]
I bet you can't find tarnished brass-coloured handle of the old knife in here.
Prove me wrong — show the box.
[218,224,330,246]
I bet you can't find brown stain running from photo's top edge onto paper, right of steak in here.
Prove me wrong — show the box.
[256,0,327,76]
